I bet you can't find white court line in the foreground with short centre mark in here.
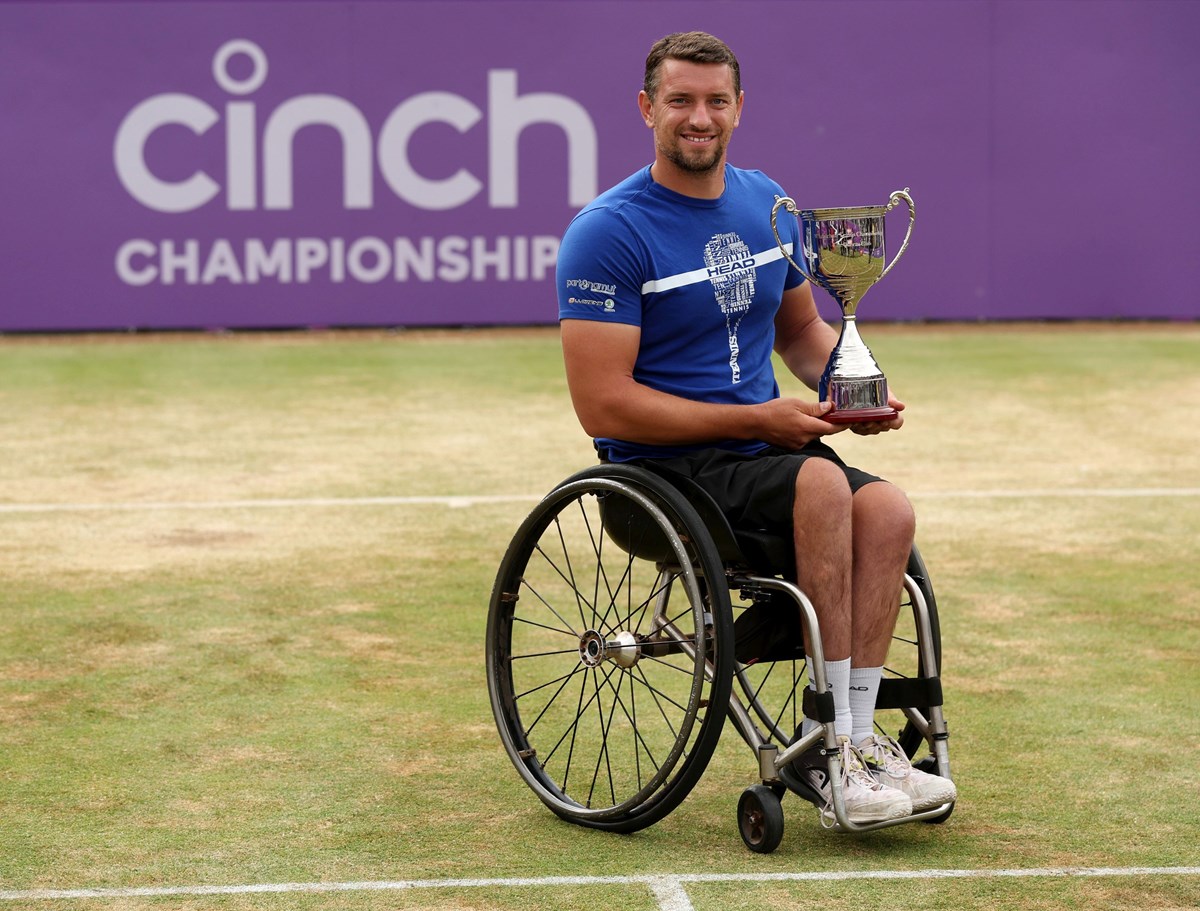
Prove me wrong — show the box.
[0,867,1200,911]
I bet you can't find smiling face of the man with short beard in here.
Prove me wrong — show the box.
[638,59,742,175]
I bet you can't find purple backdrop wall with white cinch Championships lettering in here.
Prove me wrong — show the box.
[0,0,1200,331]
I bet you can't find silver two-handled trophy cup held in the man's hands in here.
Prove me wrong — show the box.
[770,187,917,424]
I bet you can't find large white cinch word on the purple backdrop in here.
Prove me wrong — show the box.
[113,38,598,212]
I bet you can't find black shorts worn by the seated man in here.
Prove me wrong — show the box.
[644,440,881,534]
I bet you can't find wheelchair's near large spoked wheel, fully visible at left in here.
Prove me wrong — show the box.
[487,466,733,832]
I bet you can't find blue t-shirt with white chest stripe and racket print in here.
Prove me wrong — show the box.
[557,164,804,462]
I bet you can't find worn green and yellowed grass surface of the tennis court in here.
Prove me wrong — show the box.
[0,324,1200,911]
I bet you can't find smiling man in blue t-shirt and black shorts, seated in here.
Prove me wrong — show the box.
[558,32,954,822]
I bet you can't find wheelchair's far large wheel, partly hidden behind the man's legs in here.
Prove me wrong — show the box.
[733,547,942,772]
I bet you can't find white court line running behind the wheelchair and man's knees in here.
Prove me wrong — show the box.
[0,487,1200,515]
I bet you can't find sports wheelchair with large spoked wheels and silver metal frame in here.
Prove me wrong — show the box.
[486,463,954,853]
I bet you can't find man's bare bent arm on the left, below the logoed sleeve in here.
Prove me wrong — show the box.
[562,319,841,446]
